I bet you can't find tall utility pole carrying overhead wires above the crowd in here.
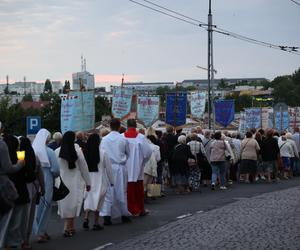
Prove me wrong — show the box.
[207,0,213,129]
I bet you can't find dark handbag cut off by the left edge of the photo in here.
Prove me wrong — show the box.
[0,176,19,214]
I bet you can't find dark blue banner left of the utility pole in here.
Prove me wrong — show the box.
[166,93,187,127]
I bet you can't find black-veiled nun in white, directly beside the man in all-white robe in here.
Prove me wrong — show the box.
[83,134,114,231]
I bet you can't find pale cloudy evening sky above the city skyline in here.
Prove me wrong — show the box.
[0,0,300,86]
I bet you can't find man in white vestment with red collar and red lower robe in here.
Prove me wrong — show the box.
[123,119,152,216]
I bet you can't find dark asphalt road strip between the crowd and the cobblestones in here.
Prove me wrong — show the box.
[32,177,300,250]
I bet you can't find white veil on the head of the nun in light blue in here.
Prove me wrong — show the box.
[32,128,50,167]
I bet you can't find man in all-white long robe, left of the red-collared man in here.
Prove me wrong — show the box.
[100,118,131,225]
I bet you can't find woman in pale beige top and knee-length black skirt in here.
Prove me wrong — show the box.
[240,131,260,183]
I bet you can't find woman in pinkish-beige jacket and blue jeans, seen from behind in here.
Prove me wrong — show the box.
[210,131,231,190]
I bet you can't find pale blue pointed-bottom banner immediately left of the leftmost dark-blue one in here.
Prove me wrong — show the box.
[137,96,159,127]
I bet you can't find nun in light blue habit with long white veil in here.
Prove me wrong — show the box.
[32,128,59,243]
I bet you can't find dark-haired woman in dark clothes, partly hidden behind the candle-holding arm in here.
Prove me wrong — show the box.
[1,135,30,249]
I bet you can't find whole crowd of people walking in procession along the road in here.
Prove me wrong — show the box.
[0,118,300,249]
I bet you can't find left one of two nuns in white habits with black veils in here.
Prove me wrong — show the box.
[55,131,91,237]
